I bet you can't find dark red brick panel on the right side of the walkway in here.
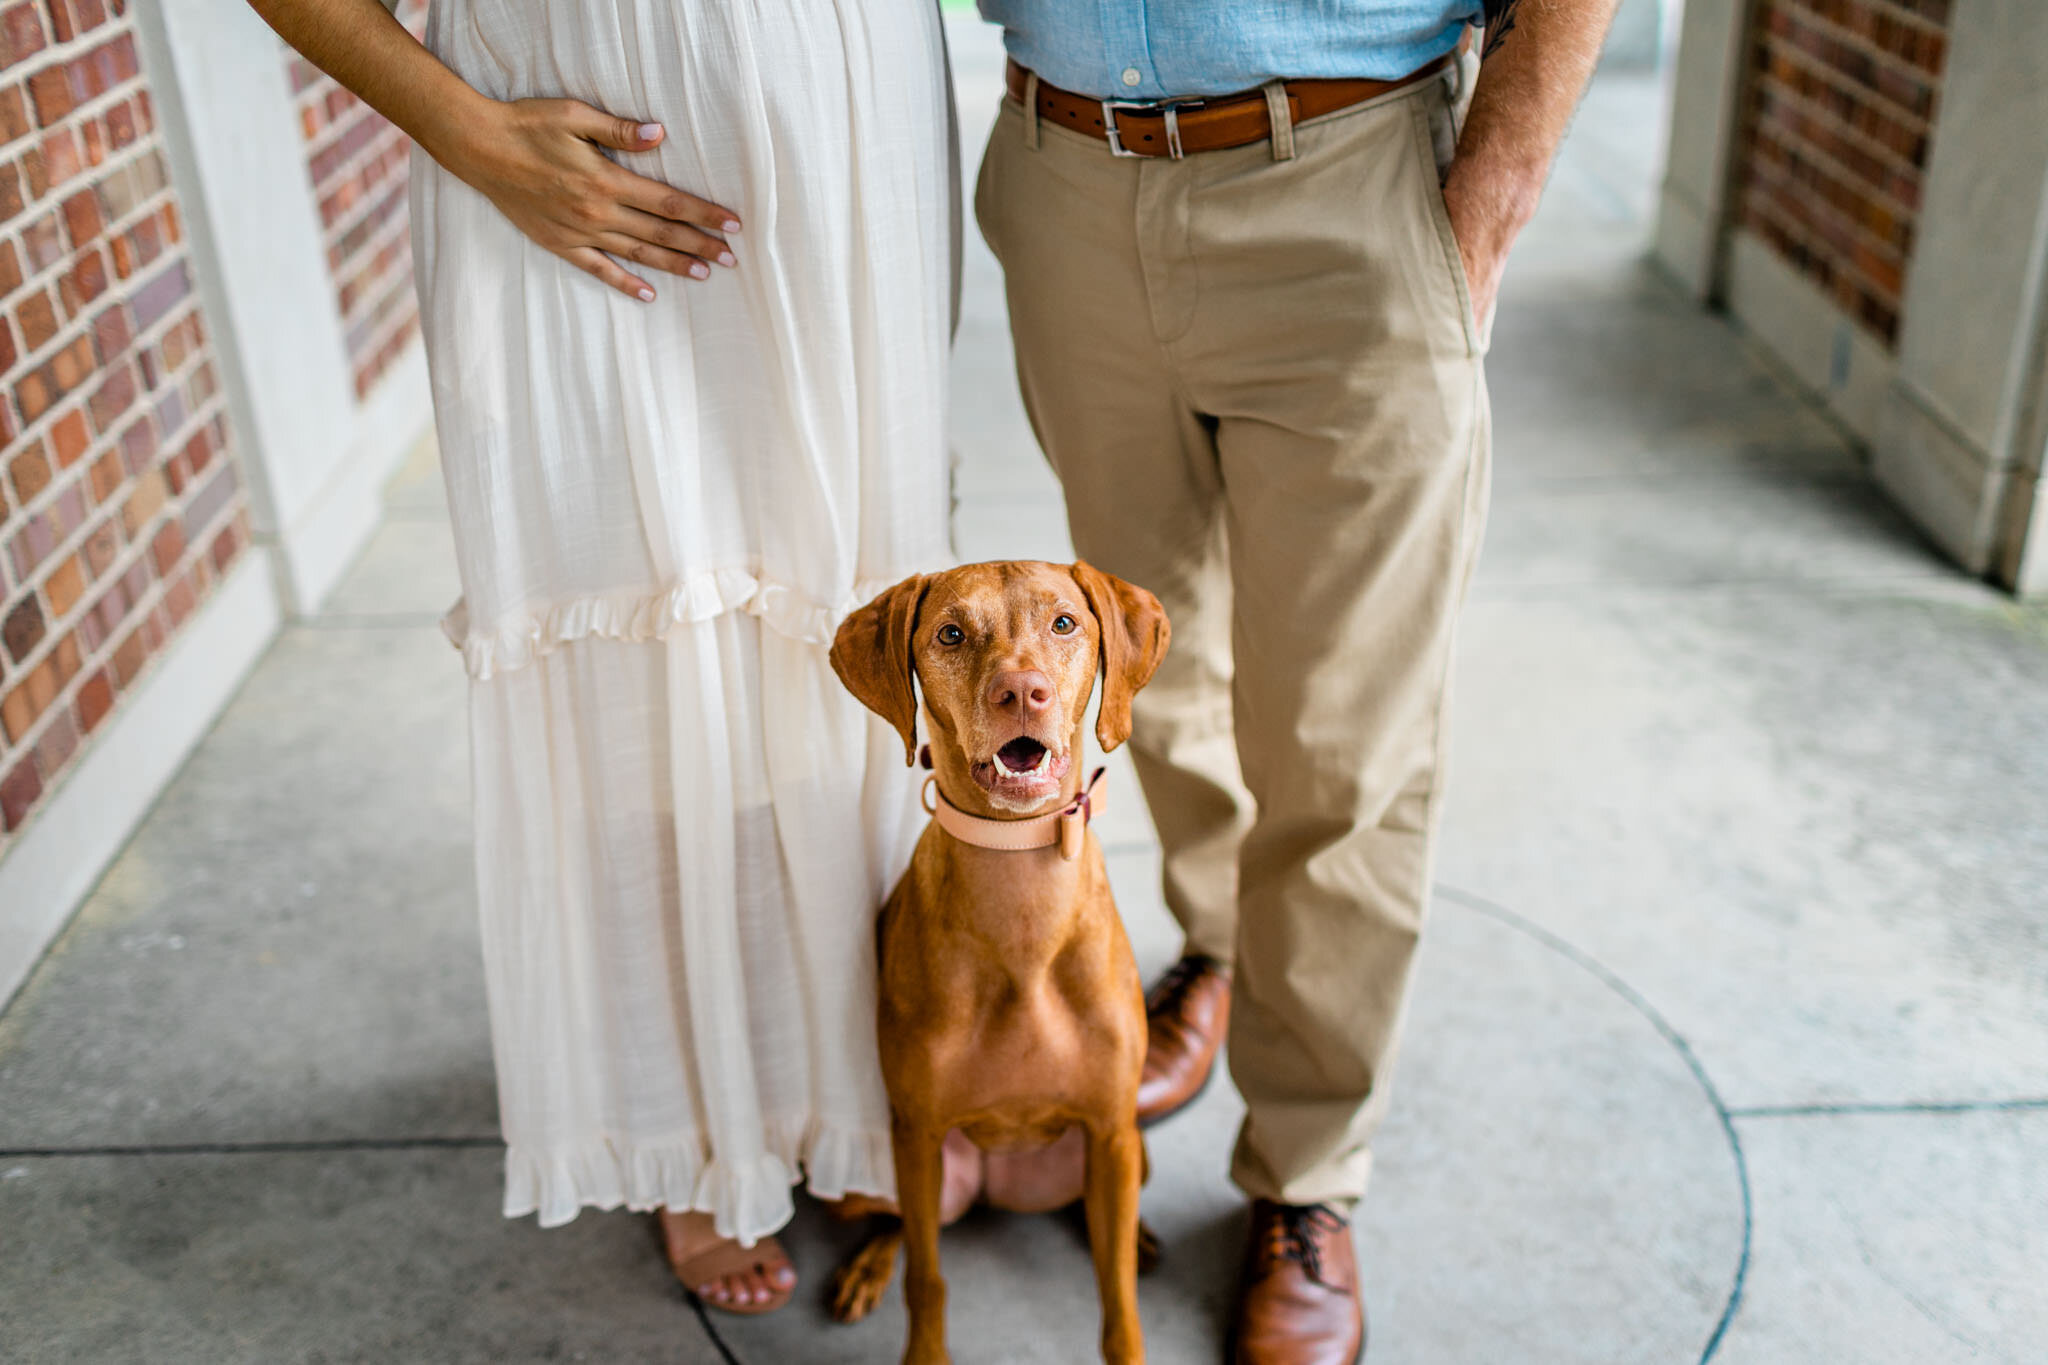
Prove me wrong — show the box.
[1737,0,1950,342]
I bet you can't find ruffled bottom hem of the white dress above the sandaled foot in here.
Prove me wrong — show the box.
[506,1119,895,1246]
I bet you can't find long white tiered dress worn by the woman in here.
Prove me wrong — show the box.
[412,0,954,1240]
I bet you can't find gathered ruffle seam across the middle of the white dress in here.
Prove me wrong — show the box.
[440,569,907,681]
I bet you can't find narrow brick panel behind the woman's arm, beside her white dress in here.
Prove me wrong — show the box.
[285,0,426,397]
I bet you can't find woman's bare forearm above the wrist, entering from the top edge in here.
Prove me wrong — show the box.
[250,0,492,170]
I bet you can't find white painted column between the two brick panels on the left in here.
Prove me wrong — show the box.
[137,0,430,614]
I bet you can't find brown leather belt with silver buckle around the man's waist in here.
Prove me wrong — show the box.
[1008,41,1464,162]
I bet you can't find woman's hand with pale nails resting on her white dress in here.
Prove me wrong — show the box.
[440,100,739,301]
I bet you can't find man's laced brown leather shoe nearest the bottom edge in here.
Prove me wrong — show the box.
[1233,1199,1366,1365]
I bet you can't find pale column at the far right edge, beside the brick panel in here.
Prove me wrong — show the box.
[1872,0,2048,591]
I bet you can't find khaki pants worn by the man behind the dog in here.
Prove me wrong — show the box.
[975,59,1489,1205]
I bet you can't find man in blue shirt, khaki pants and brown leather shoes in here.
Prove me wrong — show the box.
[975,0,1616,1365]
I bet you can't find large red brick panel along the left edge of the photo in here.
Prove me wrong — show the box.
[0,0,248,851]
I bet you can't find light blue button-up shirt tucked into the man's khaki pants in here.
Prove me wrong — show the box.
[979,0,1481,100]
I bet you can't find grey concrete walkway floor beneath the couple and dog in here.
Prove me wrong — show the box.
[0,20,2048,1365]
